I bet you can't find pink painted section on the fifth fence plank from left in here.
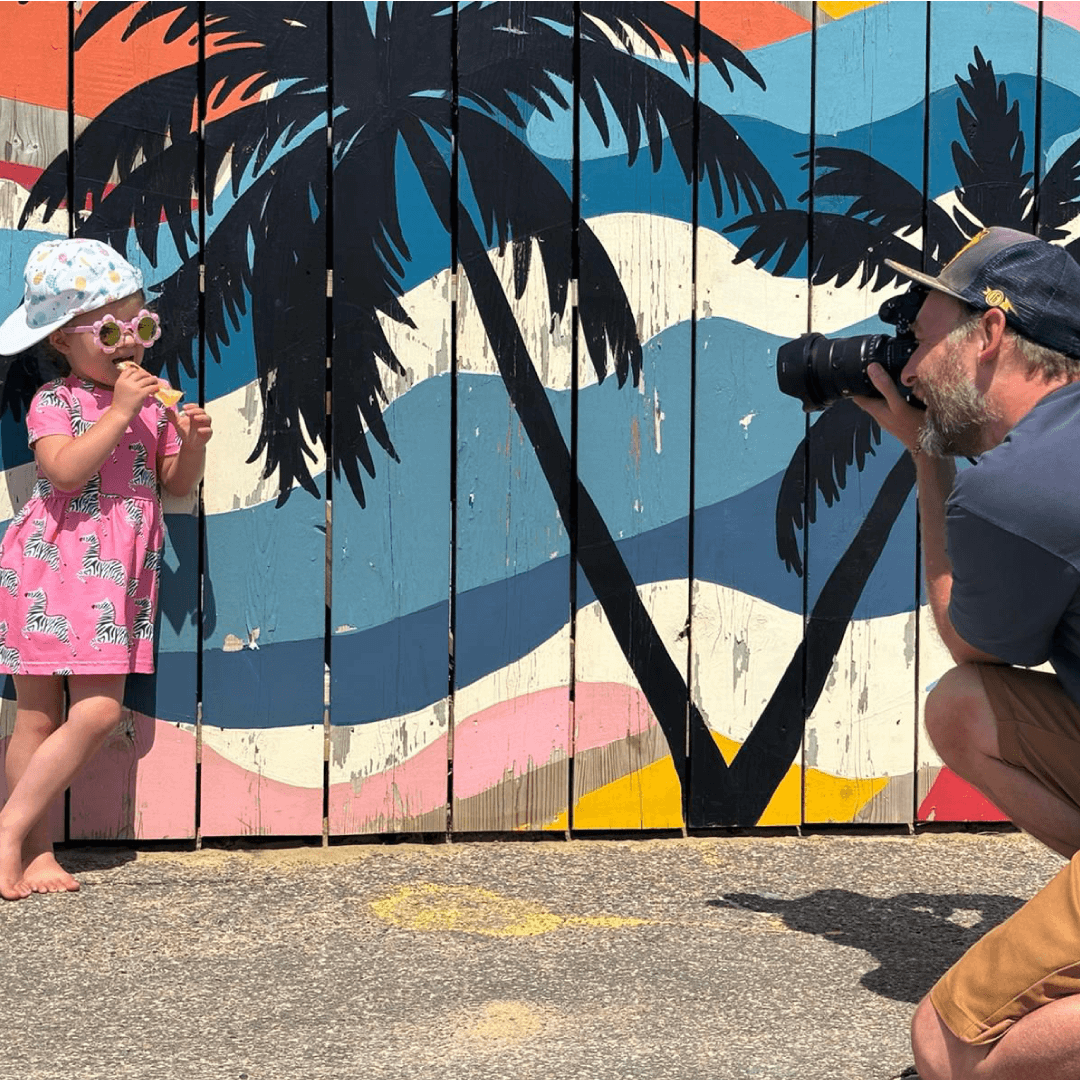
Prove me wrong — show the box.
[454,687,570,799]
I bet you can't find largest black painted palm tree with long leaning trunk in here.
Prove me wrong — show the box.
[23,0,783,823]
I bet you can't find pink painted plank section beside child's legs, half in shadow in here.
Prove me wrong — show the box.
[69,713,195,840]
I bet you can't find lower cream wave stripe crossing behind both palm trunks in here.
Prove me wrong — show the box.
[298,581,948,803]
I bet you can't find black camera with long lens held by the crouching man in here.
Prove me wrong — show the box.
[777,285,927,413]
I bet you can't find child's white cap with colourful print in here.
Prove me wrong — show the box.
[0,237,143,356]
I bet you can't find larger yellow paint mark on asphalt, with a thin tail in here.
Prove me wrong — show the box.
[370,881,649,937]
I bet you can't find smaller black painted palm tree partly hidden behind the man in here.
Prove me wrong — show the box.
[712,49,1080,815]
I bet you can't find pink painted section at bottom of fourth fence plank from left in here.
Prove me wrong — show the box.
[329,735,446,835]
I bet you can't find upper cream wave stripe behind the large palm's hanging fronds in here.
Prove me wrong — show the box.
[0,214,907,521]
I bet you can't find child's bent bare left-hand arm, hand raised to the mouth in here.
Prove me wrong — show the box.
[33,367,161,491]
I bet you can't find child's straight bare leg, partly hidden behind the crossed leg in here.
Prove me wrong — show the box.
[4,675,72,892]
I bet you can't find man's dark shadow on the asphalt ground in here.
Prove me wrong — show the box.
[708,889,1025,1004]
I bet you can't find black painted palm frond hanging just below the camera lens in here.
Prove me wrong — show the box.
[777,401,881,578]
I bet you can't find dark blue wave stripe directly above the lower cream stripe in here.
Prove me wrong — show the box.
[214,453,915,727]
